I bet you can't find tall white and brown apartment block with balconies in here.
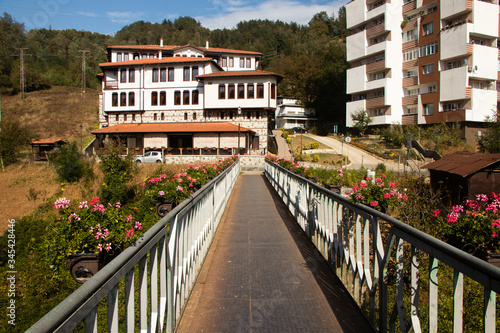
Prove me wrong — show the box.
[346,0,500,142]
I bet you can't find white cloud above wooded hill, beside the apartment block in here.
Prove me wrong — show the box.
[195,0,347,29]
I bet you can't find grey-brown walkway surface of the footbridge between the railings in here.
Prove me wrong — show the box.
[178,173,372,333]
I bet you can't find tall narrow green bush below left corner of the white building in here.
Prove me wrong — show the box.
[100,147,136,203]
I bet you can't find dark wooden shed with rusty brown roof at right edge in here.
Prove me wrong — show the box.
[423,152,500,204]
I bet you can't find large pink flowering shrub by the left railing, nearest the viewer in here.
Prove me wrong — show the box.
[45,197,143,276]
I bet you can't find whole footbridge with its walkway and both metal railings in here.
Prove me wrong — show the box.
[29,163,500,332]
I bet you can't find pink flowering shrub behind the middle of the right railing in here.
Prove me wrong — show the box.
[350,174,408,212]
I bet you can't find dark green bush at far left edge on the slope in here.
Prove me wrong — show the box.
[0,121,35,166]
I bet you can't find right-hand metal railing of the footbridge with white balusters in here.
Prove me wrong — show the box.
[266,161,500,332]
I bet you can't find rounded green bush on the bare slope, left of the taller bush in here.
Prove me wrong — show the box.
[54,141,93,183]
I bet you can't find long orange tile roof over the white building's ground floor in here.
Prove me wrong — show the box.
[91,122,253,134]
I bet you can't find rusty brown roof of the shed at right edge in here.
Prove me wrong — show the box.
[423,151,500,177]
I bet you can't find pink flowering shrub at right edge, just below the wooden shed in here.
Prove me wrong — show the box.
[433,193,500,252]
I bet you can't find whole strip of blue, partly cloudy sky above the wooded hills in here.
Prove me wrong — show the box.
[0,0,349,34]
